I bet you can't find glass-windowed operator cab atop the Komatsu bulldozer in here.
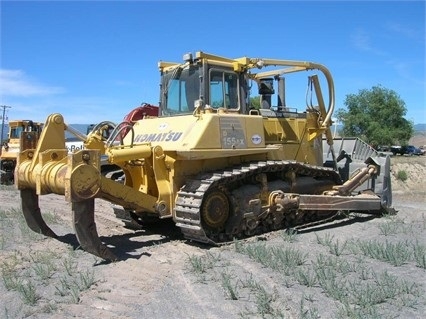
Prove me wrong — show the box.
[159,54,247,117]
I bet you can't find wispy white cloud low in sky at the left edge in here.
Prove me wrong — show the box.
[0,69,65,97]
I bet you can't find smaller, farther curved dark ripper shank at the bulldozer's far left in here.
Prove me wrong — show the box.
[21,189,58,238]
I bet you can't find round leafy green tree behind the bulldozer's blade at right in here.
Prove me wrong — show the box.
[336,85,414,146]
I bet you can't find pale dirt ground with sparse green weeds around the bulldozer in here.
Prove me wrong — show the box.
[0,156,426,319]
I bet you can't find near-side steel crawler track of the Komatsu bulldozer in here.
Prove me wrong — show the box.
[175,161,342,245]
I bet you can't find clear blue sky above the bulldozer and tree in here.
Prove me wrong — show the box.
[0,1,426,124]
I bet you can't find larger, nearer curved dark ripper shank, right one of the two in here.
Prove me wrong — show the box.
[72,198,118,261]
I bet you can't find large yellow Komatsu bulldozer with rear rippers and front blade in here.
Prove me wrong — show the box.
[15,52,393,260]
